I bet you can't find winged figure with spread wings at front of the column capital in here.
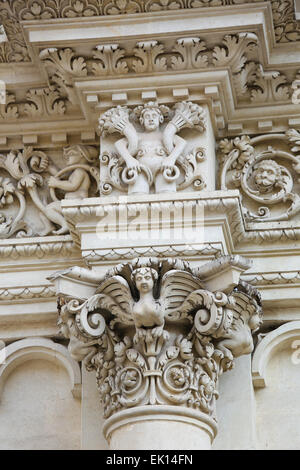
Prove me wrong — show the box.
[86,266,207,341]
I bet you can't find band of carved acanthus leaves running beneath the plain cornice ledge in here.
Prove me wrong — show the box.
[40,32,296,103]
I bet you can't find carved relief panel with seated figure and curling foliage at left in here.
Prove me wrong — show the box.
[0,145,99,238]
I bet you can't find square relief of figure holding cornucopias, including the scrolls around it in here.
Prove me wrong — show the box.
[99,102,205,195]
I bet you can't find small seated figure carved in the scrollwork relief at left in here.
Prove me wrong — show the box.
[46,145,98,235]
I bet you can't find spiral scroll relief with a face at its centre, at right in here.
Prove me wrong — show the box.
[219,129,300,222]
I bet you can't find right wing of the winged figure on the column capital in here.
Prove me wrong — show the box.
[161,269,204,320]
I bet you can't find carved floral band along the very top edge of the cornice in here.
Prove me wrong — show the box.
[0,0,300,49]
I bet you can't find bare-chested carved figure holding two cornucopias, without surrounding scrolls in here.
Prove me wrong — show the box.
[99,101,205,194]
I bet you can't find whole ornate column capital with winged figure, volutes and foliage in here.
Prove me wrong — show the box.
[52,258,262,418]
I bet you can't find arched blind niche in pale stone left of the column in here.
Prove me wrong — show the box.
[0,359,81,450]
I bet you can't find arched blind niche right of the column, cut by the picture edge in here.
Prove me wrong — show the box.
[252,321,300,450]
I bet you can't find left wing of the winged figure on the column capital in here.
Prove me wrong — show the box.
[87,276,133,325]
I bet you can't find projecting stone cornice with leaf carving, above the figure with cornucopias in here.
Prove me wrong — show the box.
[0,1,300,141]
